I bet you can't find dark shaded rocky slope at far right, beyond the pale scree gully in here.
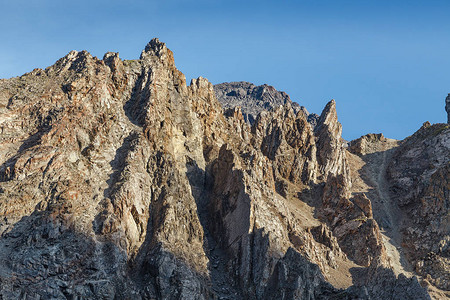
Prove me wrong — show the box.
[388,124,450,290]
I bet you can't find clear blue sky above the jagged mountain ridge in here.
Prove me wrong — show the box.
[0,0,450,140]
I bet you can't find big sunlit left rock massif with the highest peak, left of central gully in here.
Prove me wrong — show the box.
[0,40,216,298]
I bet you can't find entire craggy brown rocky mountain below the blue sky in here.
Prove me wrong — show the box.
[0,39,450,299]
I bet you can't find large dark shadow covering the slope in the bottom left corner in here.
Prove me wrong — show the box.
[0,205,129,299]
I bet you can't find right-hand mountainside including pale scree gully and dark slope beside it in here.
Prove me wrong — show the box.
[342,122,450,299]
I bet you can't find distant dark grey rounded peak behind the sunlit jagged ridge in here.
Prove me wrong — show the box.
[214,81,319,126]
